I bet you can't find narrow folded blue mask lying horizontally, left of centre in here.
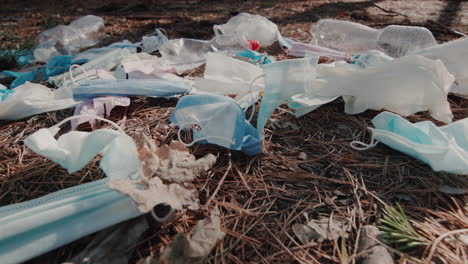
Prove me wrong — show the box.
[73,79,191,101]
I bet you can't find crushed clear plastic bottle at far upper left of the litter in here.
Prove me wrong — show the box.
[34,15,105,62]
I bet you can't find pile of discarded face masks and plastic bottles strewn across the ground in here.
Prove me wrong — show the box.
[0,13,468,263]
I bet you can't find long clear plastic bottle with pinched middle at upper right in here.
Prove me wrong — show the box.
[311,19,437,57]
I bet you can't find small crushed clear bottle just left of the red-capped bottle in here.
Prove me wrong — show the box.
[159,38,218,65]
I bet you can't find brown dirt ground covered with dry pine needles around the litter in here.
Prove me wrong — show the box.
[0,0,468,263]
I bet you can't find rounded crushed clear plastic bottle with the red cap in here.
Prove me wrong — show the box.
[213,13,279,47]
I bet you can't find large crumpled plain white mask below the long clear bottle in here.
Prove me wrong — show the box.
[306,55,454,123]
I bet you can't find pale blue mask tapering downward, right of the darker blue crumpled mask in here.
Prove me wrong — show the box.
[257,57,318,134]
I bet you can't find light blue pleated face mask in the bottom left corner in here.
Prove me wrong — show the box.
[0,176,142,264]
